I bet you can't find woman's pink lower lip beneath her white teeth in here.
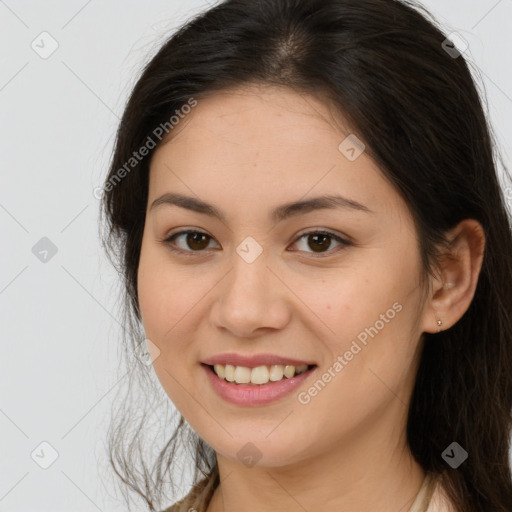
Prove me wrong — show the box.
[201,364,317,406]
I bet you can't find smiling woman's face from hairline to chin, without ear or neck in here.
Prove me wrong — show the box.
[138,87,435,466]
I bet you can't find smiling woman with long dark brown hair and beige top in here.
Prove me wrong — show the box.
[103,0,512,512]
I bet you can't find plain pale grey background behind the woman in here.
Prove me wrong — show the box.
[0,0,512,512]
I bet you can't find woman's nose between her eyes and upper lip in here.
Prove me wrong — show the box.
[210,249,291,338]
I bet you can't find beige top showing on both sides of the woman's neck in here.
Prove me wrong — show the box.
[162,470,453,512]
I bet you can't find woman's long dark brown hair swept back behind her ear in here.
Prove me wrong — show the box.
[102,0,512,512]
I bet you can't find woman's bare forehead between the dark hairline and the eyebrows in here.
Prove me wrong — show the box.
[150,86,403,224]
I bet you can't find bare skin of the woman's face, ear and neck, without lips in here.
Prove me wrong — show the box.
[138,85,485,512]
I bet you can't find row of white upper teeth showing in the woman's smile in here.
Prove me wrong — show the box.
[213,364,308,384]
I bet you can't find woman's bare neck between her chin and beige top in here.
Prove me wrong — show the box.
[208,424,425,512]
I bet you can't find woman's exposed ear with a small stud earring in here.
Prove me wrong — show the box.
[422,219,485,333]
